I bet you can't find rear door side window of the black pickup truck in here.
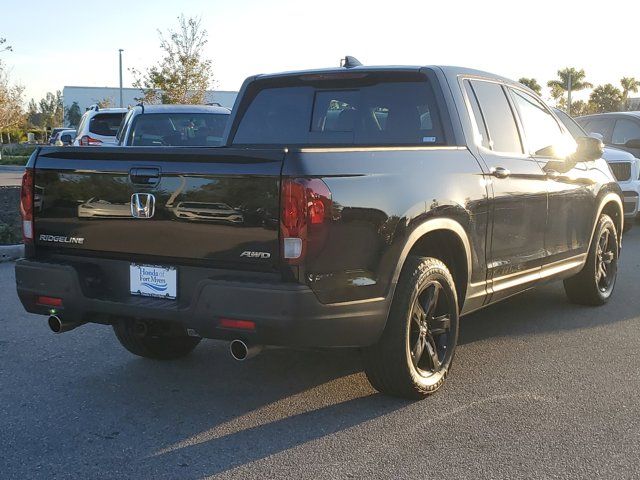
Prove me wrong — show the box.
[471,80,522,153]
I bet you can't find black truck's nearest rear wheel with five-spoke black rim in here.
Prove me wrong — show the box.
[363,257,459,399]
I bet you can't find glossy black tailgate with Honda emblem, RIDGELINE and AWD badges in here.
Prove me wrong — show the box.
[34,148,284,270]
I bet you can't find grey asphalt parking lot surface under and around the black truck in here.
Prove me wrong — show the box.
[0,226,640,479]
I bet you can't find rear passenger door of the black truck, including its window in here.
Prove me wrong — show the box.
[464,79,547,300]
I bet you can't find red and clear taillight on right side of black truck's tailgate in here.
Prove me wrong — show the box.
[280,178,331,264]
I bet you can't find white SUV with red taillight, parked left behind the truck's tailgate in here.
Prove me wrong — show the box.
[73,105,128,147]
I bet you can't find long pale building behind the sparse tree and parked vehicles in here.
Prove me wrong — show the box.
[62,86,238,121]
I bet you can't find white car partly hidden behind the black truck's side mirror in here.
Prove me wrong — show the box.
[553,108,640,225]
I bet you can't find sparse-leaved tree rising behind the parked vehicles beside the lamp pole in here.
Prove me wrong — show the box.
[131,15,213,104]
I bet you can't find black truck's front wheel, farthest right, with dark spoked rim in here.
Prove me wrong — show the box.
[564,213,619,306]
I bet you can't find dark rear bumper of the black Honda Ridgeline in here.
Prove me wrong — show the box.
[16,260,389,347]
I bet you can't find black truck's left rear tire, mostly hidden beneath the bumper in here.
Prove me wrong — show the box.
[113,320,201,360]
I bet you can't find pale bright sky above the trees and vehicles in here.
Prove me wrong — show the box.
[0,0,640,105]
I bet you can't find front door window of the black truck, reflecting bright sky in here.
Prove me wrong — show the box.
[511,90,567,154]
